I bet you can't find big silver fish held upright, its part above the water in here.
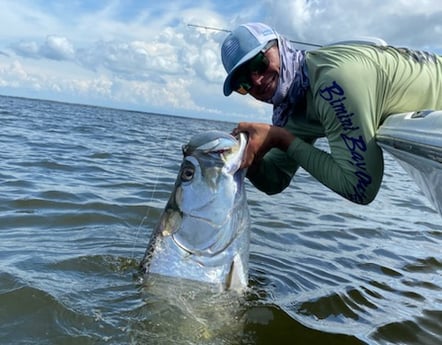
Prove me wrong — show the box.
[141,131,250,290]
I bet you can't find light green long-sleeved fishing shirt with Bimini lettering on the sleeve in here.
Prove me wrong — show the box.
[248,45,442,204]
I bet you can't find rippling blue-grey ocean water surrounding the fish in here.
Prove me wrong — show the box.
[0,97,442,345]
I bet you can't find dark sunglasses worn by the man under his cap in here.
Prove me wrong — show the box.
[232,40,276,95]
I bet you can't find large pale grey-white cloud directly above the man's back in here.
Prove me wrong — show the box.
[266,0,442,48]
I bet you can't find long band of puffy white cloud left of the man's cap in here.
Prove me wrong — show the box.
[10,20,225,83]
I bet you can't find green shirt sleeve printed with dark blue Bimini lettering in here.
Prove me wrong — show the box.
[287,58,386,204]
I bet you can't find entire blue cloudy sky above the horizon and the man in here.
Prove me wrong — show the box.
[0,0,442,122]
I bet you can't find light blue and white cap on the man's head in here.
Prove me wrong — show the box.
[221,23,277,96]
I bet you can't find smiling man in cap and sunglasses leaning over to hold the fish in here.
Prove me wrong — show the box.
[221,23,442,204]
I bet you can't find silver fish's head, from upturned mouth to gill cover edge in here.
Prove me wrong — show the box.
[173,132,247,256]
